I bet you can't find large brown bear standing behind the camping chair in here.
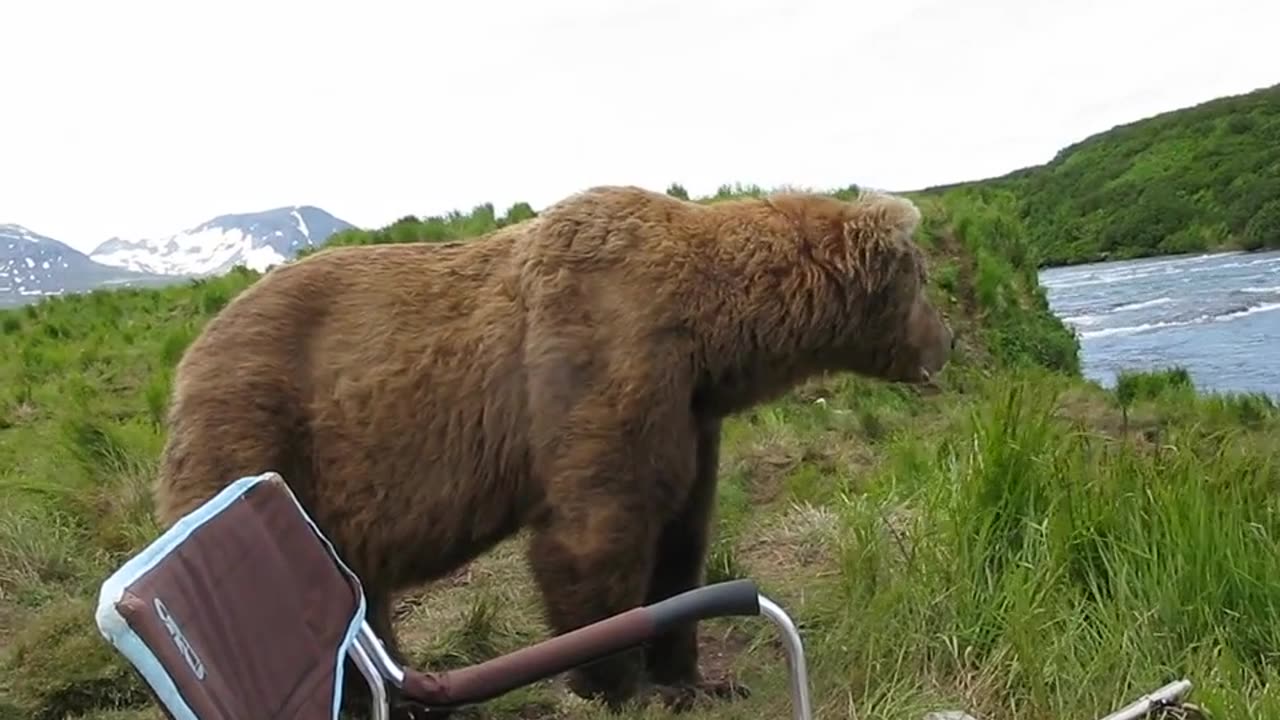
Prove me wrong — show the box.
[156,187,952,707]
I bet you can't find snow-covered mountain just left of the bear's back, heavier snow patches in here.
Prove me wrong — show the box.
[88,205,353,275]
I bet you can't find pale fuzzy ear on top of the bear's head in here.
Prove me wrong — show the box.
[841,192,923,293]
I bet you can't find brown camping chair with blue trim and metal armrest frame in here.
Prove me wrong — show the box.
[96,473,810,720]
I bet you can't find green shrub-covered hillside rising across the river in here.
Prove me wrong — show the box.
[916,85,1280,265]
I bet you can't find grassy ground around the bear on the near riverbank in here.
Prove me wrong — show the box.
[0,180,1280,720]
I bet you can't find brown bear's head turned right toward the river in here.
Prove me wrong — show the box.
[815,193,955,387]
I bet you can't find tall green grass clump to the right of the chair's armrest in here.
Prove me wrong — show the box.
[778,374,1280,717]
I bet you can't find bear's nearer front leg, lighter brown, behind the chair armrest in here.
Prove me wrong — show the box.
[529,397,694,710]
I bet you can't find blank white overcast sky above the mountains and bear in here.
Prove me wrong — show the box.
[0,0,1280,250]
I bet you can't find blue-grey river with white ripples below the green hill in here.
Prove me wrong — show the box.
[1041,251,1280,398]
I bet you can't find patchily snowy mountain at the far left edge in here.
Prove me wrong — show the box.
[0,224,175,306]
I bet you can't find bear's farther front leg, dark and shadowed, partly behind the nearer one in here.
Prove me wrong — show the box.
[645,419,750,710]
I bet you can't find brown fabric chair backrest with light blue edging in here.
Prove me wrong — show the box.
[96,473,365,720]
